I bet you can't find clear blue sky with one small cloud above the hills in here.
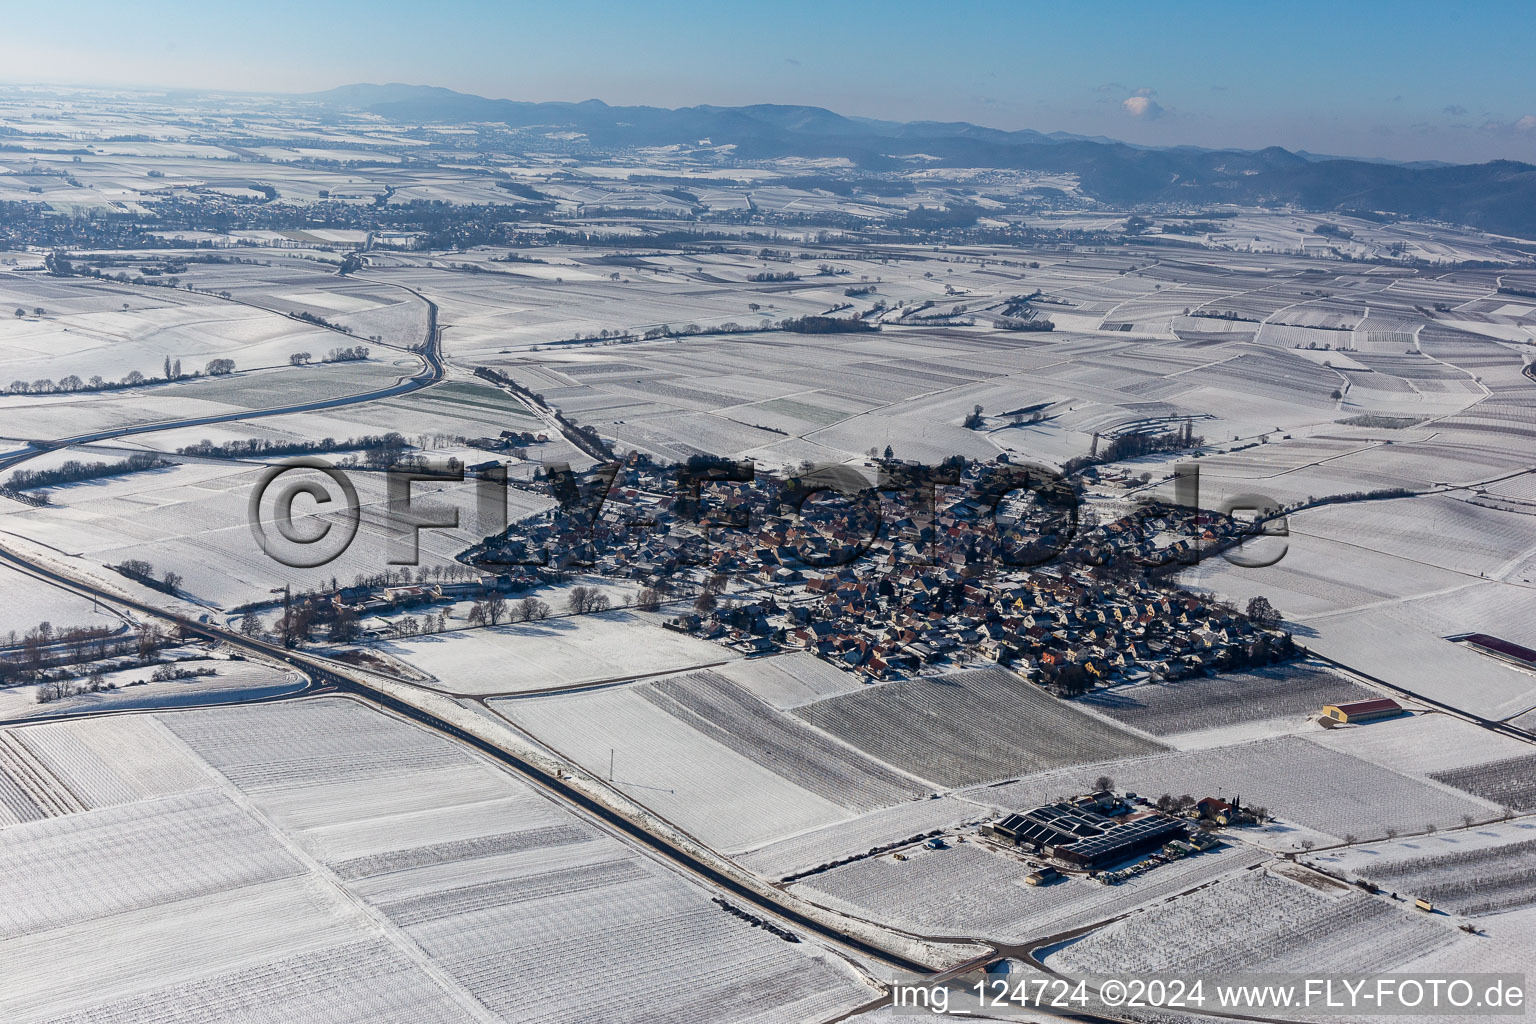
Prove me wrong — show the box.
[0,0,1536,161]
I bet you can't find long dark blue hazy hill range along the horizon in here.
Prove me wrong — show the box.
[304,84,1536,238]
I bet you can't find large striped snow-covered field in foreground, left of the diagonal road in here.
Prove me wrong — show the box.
[0,699,874,1024]
